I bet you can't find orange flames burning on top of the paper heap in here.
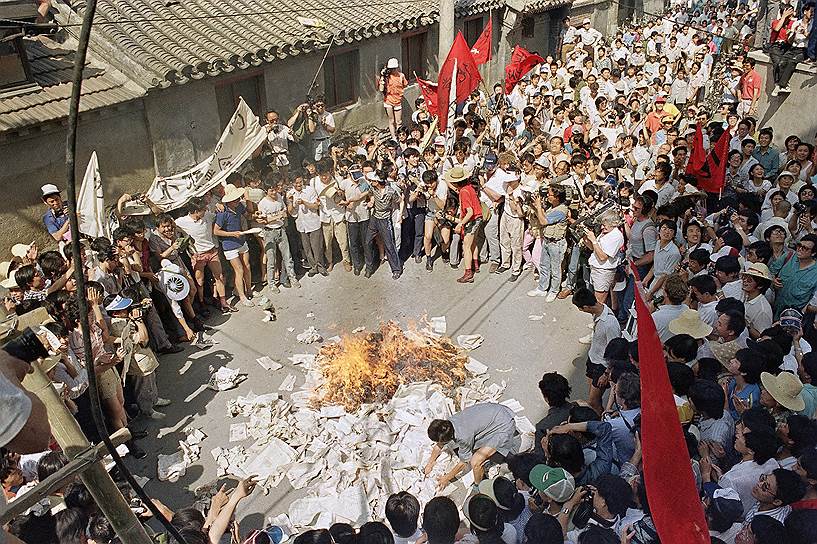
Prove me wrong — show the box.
[316,321,468,411]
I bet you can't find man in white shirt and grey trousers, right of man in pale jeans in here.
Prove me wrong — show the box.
[287,175,329,277]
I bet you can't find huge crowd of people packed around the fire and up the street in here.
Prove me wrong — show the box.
[0,0,817,544]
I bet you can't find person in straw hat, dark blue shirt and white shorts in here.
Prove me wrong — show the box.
[213,184,253,306]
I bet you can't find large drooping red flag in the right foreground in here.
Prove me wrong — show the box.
[633,267,710,544]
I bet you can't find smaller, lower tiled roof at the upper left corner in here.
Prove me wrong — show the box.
[0,36,144,132]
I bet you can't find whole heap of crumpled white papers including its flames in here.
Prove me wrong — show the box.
[211,323,534,529]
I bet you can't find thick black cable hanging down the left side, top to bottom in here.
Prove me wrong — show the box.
[65,0,187,544]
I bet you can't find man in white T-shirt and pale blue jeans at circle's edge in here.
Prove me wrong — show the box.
[256,184,301,293]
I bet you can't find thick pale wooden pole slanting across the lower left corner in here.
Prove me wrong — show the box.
[23,361,152,544]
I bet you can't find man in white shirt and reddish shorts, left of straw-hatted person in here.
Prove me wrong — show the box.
[176,198,232,312]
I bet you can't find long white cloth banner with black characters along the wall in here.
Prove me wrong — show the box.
[146,98,267,211]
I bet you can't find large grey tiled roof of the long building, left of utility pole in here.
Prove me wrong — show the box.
[73,0,444,87]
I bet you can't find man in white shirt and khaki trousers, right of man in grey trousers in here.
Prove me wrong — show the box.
[311,157,352,272]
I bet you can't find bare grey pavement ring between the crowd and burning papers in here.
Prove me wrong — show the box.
[122,261,590,534]
